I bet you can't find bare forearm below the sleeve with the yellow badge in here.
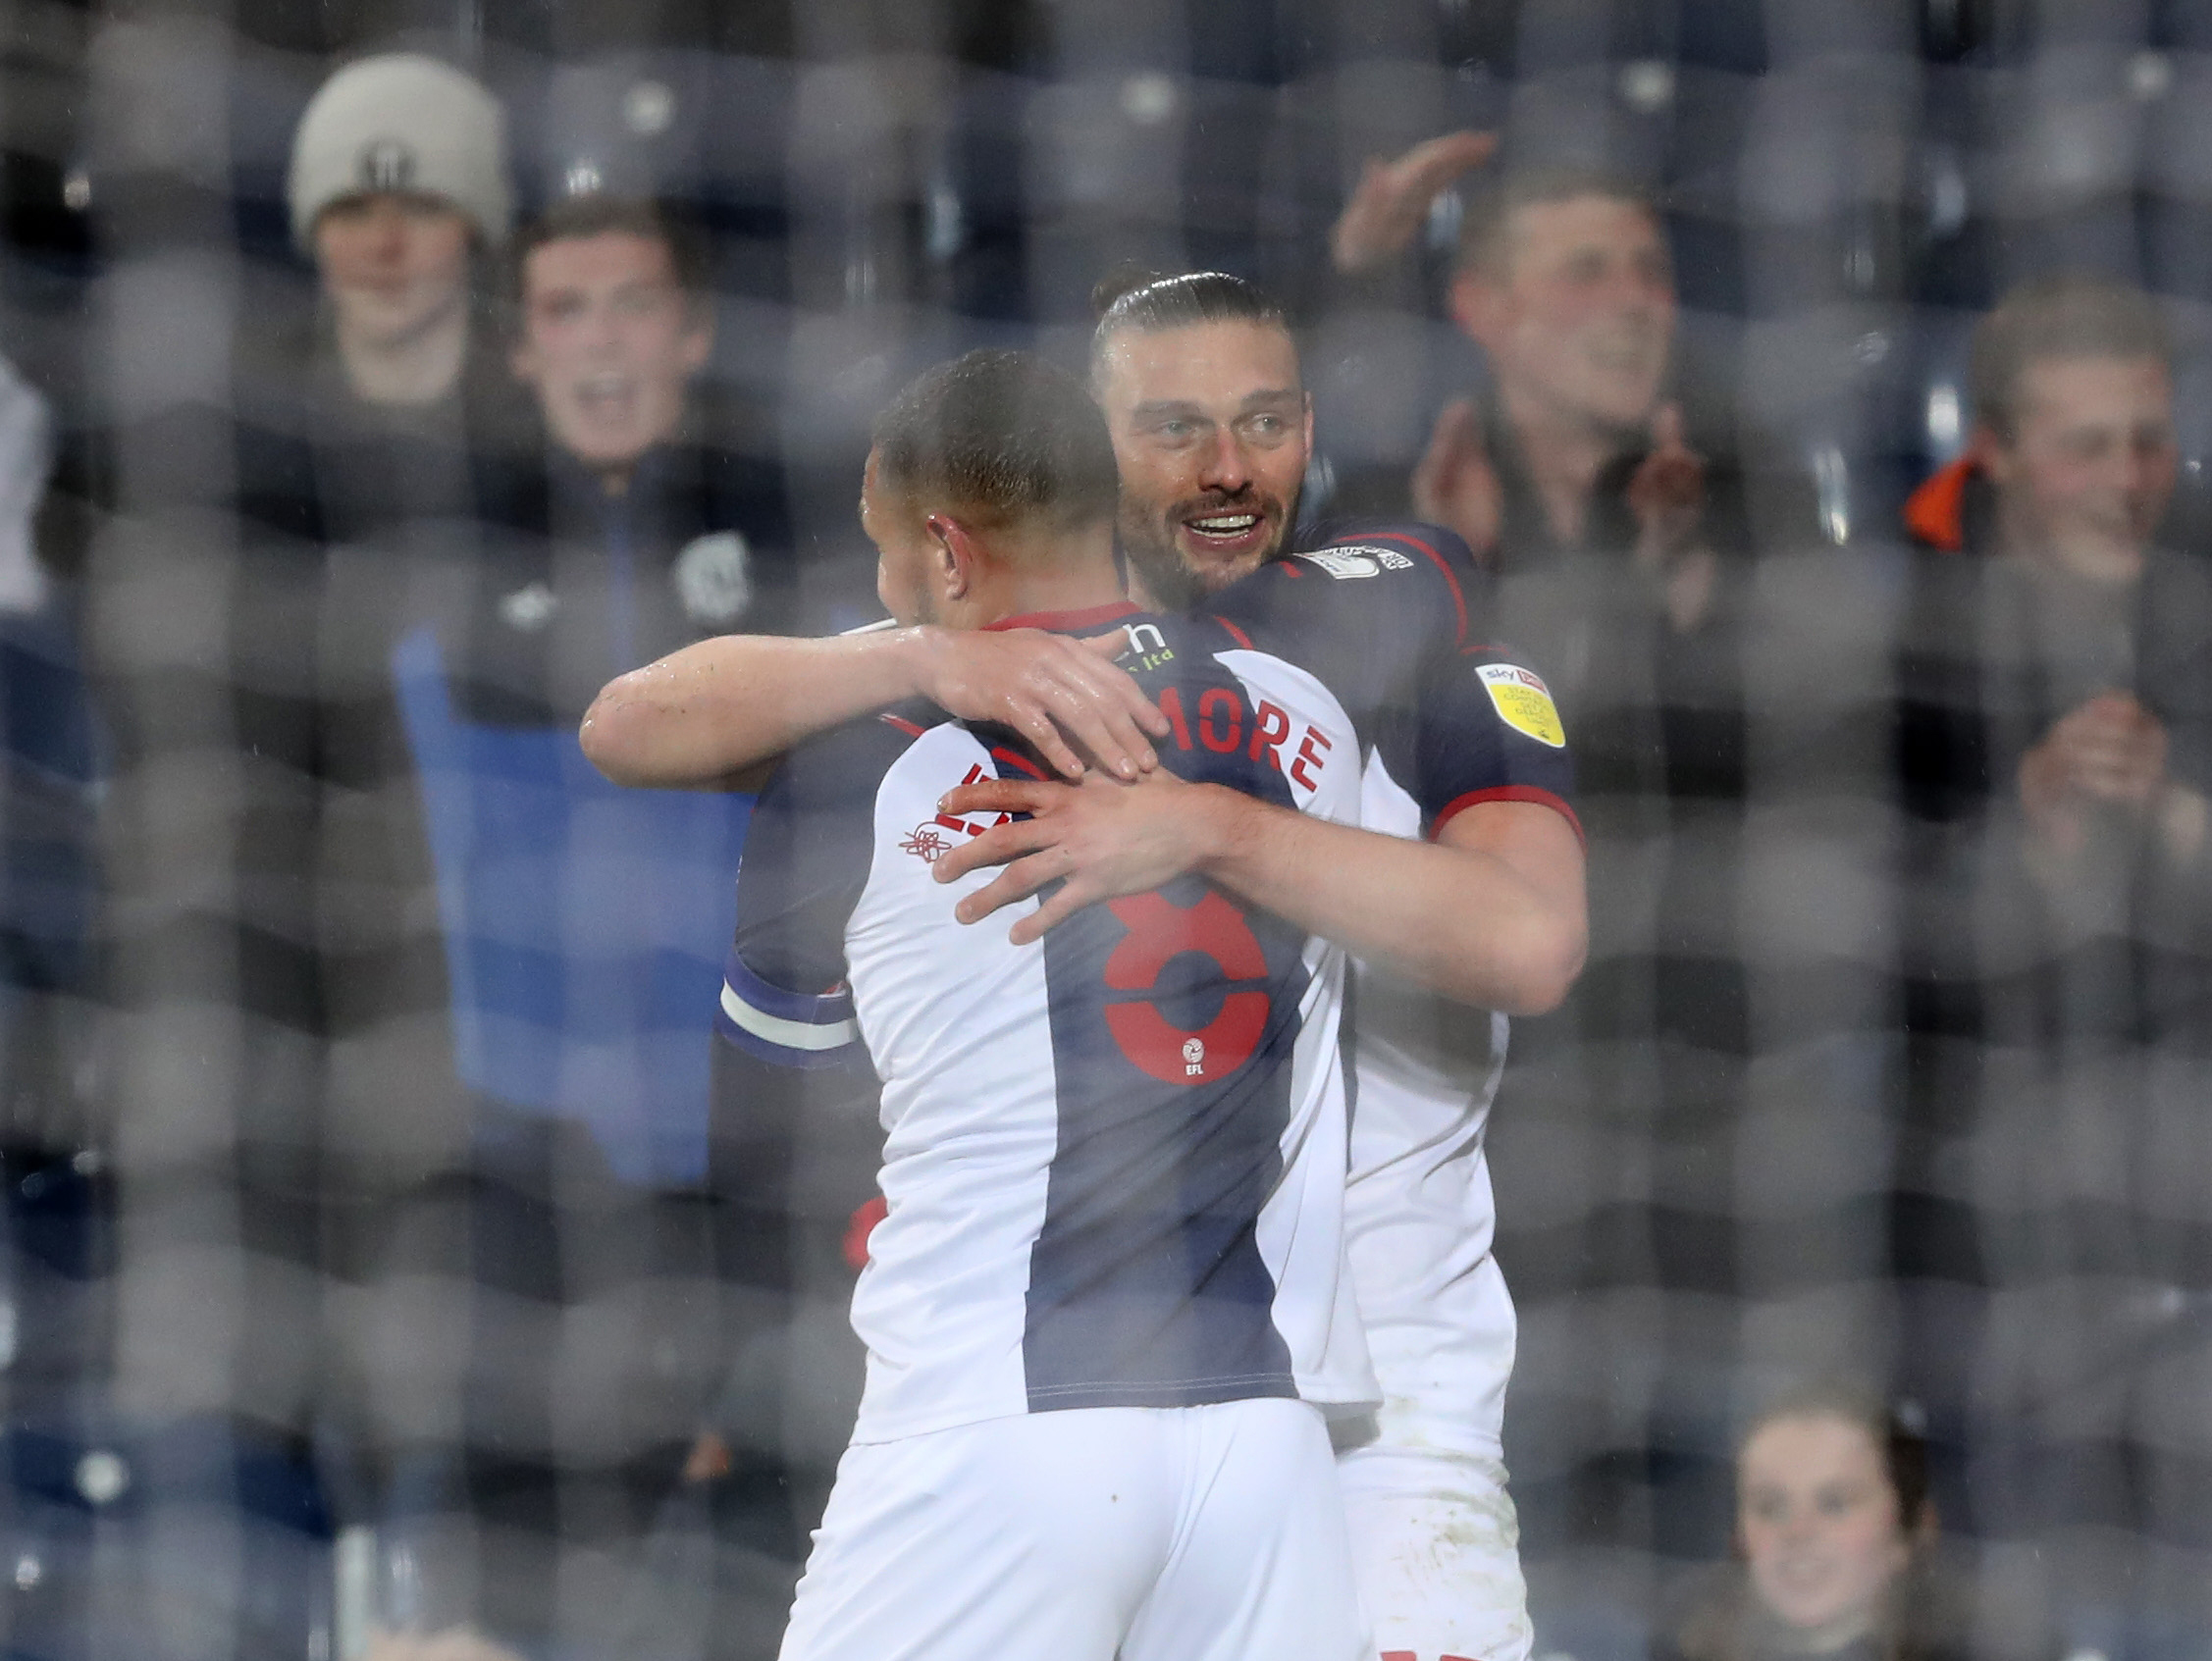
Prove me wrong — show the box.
[1194,788,1588,1015]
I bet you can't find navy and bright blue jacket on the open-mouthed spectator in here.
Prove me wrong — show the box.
[387,418,796,1185]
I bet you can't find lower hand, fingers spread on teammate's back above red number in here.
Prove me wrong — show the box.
[931,767,1230,947]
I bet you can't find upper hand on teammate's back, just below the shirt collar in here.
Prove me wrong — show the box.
[922,628,1168,779]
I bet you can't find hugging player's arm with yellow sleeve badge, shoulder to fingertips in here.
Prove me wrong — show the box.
[938,524,1588,1015]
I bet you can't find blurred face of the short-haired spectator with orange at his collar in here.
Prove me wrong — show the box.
[1982,356,2181,582]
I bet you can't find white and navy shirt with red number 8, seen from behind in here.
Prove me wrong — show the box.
[721,528,1564,1442]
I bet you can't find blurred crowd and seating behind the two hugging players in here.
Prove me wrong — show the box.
[0,0,2212,1661]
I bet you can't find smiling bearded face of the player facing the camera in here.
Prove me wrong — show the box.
[1097,321,1314,610]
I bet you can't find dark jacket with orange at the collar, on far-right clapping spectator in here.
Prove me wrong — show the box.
[1893,460,2212,1040]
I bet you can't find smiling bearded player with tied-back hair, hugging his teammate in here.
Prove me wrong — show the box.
[584,275,1586,1661]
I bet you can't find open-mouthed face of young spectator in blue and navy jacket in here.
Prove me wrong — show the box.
[513,230,712,478]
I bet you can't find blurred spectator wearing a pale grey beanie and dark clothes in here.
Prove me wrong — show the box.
[88,42,522,1652]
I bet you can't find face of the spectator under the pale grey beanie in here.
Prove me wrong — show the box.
[314,190,469,349]
